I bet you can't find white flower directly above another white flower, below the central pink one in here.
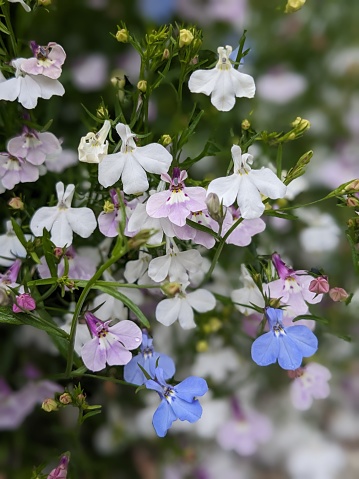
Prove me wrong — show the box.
[148,238,202,283]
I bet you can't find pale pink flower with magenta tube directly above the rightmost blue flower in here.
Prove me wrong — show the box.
[263,253,323,316]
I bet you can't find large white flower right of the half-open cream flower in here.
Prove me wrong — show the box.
[98,123,172,194]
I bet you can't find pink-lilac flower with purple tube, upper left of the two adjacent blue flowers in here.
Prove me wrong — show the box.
[81,312,142,371]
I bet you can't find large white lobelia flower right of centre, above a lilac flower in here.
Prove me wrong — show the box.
[207,145,287,220]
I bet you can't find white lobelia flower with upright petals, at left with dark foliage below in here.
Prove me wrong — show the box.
[30,181,97,248]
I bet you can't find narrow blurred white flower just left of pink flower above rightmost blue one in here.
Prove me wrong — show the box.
[231,264,264,315]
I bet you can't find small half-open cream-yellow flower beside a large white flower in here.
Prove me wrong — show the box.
[78,120,111,163]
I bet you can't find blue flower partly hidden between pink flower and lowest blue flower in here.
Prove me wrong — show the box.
[124,329,176,386]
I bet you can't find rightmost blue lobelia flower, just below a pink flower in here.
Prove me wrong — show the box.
[251,308,318,369]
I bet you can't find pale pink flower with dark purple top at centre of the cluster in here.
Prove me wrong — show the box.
[146,167,207,226]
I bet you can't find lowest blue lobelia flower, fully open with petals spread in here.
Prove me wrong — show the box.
[145,368,208,437]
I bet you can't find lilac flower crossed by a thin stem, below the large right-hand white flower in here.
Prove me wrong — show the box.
[221,206,266,246]
